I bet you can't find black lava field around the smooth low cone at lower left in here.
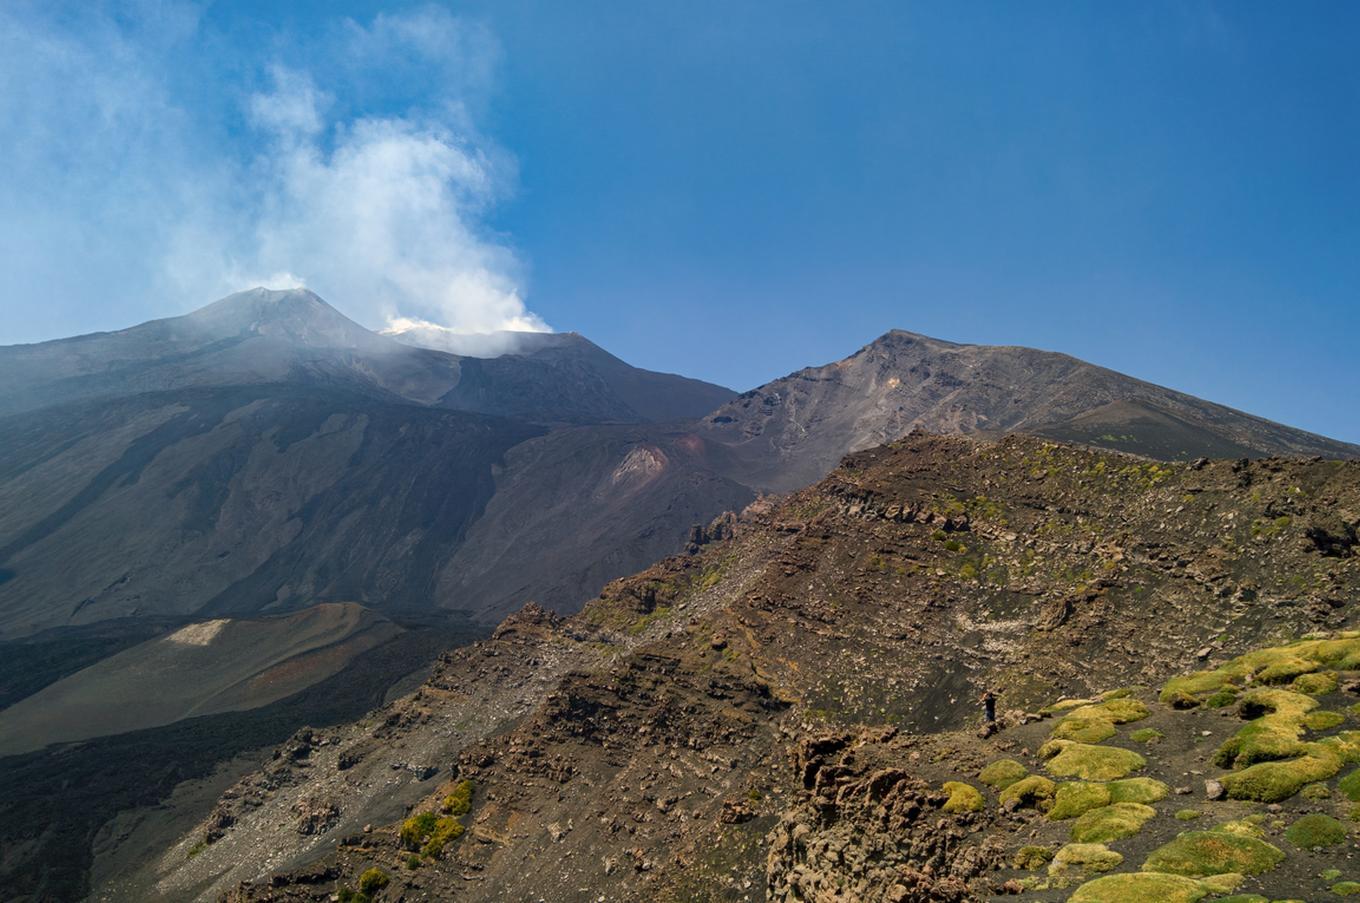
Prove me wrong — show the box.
[0,615,480,903]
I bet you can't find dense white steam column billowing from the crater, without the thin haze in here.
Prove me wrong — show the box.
[233,59,545,332]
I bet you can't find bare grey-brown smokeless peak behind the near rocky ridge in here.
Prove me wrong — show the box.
[704,330,1360,491]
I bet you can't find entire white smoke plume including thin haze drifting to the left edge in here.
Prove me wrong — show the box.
[0,3,548,341]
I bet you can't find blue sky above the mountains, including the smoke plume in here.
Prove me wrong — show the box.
[0,0,1360,442]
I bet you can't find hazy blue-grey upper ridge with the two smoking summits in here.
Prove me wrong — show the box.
[0,288,736,423]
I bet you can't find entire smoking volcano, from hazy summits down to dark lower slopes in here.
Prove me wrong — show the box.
[0,290,749,638]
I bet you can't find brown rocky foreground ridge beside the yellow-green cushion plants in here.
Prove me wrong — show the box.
[119,435,1360,900]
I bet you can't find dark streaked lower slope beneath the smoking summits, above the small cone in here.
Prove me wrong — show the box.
[0,384,543,636]
